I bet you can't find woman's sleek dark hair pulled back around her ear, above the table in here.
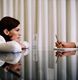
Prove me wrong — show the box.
[0,16,20,41]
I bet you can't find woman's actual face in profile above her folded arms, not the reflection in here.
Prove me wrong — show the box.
[8,25,21,41]
